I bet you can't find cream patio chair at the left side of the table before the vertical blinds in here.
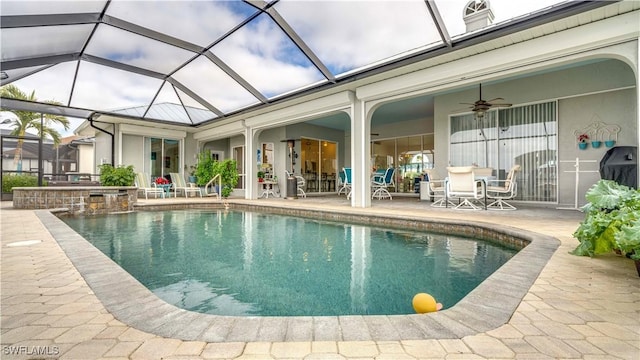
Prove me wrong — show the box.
[445,166,485,210]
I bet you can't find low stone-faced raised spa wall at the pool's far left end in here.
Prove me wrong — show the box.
[13,186,138,215]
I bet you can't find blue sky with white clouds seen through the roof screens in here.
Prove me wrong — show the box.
[0,0,562,136]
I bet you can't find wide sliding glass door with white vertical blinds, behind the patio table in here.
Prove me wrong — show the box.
[449,102,557,202]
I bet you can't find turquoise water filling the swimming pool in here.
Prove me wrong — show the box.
[63,210,517,316]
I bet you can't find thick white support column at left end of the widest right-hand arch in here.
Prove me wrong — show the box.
[351,99,371,208]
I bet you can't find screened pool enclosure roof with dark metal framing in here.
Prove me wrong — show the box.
[0,0,610,129]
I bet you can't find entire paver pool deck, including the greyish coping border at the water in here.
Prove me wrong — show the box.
[0,196,640,360]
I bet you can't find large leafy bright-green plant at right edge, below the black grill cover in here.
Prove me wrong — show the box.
[571,180,640,276]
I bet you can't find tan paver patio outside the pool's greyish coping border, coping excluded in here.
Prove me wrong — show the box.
[0,197,640,360]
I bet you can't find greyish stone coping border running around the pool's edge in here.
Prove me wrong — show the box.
[36,202,559,342]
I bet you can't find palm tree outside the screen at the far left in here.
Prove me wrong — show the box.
[0,85,69,172]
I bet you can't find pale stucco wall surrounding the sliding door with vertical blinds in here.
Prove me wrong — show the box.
[434,59,638,206]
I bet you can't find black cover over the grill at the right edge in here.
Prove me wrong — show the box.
[600,146,638,189]
